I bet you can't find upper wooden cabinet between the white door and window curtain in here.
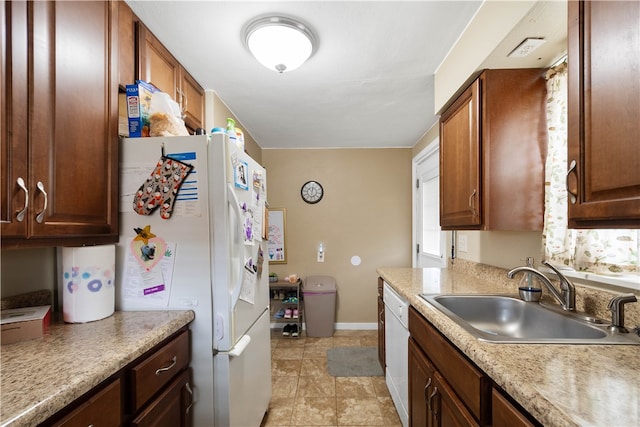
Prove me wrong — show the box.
[440,69,547,231]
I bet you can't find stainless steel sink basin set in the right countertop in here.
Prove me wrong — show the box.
[421,294,640,345]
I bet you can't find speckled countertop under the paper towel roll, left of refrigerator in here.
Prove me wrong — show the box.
[0,311,194,427]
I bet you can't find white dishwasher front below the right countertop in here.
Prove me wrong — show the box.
[383,282,409,427]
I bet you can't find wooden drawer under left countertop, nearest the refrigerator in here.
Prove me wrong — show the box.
[131,331,189,411]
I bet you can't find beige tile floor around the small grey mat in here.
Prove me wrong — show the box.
[262,330,402,427]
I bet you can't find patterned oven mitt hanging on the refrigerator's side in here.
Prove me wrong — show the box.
[133,155,193,219]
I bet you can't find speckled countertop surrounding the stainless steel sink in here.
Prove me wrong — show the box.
[377,268,640,427]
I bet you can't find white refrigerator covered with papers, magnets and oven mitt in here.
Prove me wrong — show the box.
[116,135,271,427]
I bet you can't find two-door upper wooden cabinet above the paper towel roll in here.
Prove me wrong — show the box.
[0,1,118,248]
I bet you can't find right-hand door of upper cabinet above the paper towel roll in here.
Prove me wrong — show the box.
[17,1,118,244]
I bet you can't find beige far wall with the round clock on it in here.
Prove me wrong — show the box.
[262,148,411,323]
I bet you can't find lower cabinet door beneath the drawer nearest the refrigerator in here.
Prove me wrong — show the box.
[131,369,193,427]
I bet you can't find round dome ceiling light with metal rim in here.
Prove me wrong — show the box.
[244,16,316,73]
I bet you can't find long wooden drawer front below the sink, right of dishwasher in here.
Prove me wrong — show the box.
[409,307,491,424]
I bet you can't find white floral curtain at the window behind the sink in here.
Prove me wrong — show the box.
[542,63,640,274]
